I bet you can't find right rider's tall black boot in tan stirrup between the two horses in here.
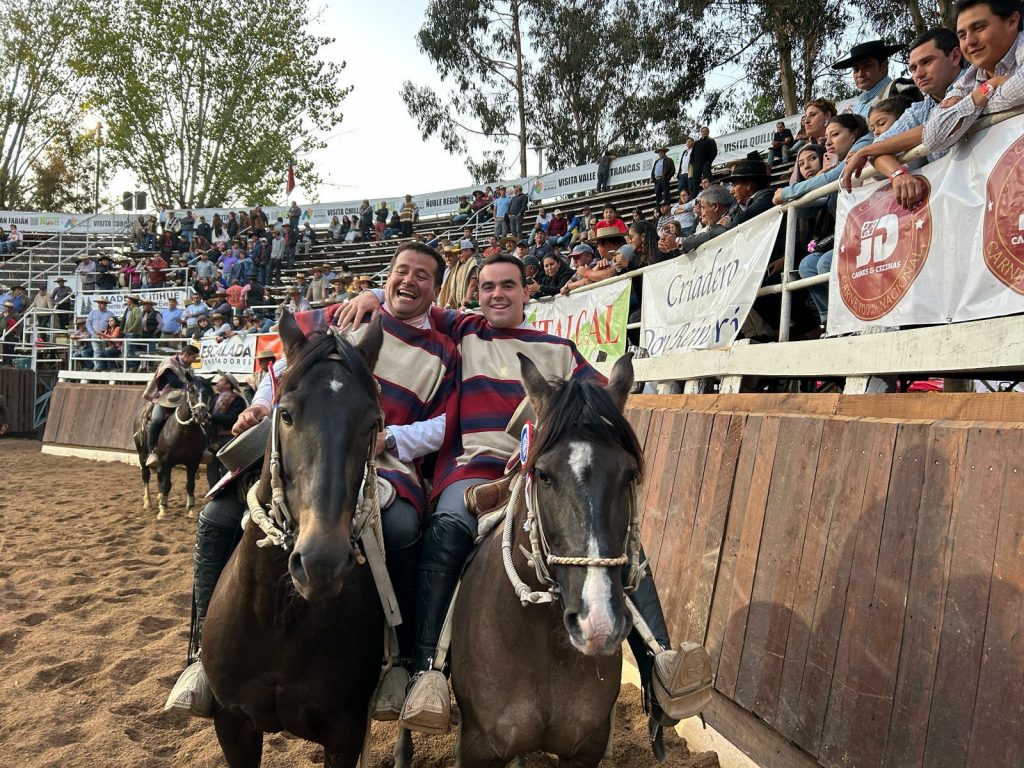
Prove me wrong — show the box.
[400,519,473,733]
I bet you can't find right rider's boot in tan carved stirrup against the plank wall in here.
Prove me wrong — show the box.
[629,572,712,726]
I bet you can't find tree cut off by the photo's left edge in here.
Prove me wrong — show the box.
[0,0,91,209]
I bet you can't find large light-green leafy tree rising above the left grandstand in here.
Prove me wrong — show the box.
[84,0,350,207]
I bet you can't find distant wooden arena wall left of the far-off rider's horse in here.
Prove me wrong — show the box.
[43,382,143,451]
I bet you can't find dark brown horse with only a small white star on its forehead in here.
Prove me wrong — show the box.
[202,313,384,768]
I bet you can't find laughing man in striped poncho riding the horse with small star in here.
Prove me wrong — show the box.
[165,242,457,720]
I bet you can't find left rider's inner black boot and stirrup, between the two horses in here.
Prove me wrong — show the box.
[374,538,422,721]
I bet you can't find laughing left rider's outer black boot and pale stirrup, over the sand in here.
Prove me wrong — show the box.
[164,514,238,718]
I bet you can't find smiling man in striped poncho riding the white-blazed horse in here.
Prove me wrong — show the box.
[339,254,708,733]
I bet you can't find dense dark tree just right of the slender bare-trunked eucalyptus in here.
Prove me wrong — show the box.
[530,0,719,168]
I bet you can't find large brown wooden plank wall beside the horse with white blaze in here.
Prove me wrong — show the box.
[627,403,1024,768]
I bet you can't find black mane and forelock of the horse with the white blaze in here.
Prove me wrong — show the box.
[527,379,643,479]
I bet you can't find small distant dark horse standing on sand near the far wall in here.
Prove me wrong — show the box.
[135,376,213,520]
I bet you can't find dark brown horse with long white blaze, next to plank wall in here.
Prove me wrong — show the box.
[451,354,643,768]
